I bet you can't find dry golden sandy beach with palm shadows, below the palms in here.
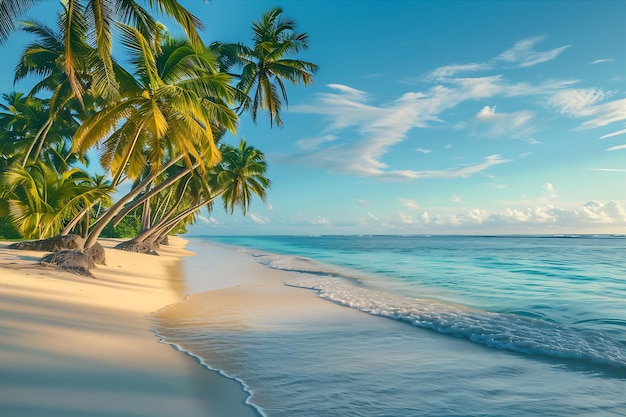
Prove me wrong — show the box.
[0,239,255,417]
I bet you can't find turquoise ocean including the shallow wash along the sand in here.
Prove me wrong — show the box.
[150,235,626,417]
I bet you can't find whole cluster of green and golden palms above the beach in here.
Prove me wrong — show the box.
[0,0,318,270]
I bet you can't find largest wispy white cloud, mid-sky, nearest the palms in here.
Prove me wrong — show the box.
[282,77,530,179]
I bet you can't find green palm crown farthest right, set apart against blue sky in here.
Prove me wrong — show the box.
[212,8,318,127]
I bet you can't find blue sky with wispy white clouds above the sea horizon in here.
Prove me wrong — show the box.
[0,0,626,234]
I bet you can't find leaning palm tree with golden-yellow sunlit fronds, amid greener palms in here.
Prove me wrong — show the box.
[74,25,237,248]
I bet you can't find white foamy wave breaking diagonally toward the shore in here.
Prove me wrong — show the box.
[285,274,626,371]
